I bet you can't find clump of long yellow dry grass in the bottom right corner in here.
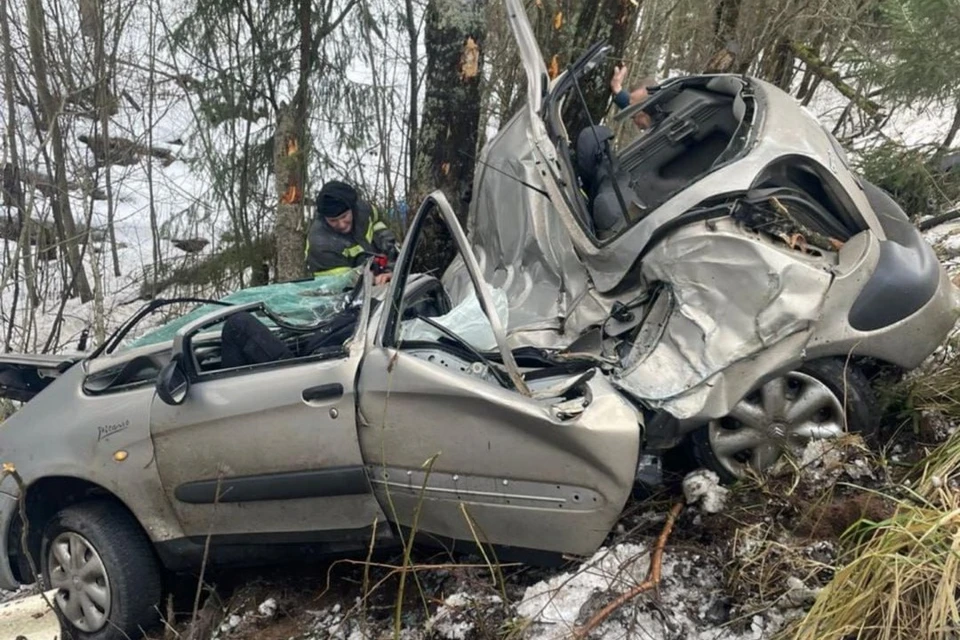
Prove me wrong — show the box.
[782,362,960,640]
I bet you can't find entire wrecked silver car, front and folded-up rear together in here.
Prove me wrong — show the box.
[0,0,958,640]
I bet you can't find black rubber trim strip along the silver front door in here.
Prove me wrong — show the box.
[174,466,370,504]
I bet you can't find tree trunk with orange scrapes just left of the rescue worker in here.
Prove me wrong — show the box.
[273,0,311,282]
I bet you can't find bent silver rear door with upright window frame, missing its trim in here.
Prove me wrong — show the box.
[358,192,640,557]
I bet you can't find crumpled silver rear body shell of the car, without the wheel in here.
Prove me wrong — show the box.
[458,2,960,424]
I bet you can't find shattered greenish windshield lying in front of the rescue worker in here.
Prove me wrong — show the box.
[120,268,361,351]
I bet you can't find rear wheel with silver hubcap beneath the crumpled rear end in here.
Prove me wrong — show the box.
[691,358,879,483]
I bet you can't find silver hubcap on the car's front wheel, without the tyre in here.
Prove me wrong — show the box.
[47,531,110,633]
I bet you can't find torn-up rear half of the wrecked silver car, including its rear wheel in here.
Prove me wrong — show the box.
[454,0,958,479]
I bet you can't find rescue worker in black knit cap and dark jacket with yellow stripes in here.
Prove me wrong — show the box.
[306,180,397,285]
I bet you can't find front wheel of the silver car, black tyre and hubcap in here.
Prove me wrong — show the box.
[41,501,161,640]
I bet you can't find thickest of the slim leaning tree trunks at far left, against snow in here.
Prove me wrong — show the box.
[27,0,93,302]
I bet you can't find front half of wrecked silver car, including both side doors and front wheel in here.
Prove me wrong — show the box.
[0,193,641,639]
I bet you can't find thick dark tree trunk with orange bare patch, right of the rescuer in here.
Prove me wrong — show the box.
[413,0,486,224]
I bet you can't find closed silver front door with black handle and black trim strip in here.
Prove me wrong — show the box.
[150,288,385,540]
